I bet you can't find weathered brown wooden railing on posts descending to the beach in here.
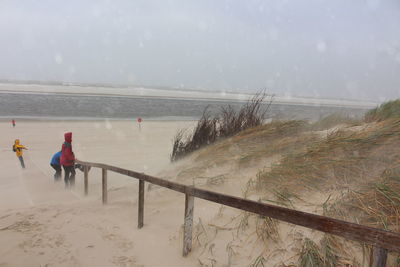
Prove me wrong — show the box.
[76,160,400,267]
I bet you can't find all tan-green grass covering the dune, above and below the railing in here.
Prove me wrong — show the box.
[169,104,400,266]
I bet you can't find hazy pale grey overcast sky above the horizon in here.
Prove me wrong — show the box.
[0,0,400,101]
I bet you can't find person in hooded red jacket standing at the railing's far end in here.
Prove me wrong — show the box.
[60,132,75,188]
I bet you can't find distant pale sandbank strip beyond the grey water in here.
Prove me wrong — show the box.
[0,83,380,108]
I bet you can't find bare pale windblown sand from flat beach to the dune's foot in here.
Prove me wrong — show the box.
[0,120,292,267]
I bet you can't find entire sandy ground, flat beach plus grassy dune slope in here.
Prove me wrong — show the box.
[0,112,400,267]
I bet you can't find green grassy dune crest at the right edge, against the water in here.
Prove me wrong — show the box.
[364,99,400,122]
